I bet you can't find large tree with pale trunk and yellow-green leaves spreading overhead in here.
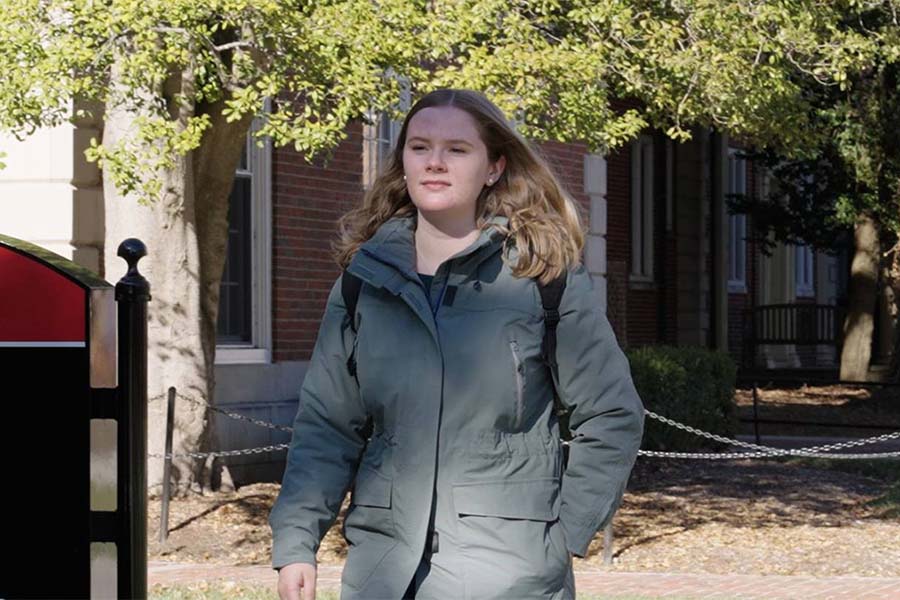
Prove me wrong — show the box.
[0,0,872,489]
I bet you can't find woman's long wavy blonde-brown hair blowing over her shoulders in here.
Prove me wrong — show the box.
[333,89,584,283]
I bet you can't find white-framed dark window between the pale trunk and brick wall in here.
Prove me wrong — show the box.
[216,113,272,364]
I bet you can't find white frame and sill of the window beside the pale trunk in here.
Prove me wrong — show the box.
[216,101,272,365]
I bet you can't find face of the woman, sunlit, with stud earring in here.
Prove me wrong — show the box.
[403,106,506,222]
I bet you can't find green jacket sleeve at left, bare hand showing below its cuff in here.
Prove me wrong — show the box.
[269,278,366,569]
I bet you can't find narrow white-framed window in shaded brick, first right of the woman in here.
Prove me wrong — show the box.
[631,135,653,281]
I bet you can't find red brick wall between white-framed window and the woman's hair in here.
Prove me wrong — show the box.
[272,124,363,361]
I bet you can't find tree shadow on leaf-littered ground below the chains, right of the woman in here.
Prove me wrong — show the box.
[590,458,900,556]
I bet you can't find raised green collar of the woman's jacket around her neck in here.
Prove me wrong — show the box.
[351,215,509,281]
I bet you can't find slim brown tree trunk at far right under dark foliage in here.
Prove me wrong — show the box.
[840,213,881,381]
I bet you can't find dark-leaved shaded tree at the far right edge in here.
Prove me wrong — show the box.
[732,2,900,380]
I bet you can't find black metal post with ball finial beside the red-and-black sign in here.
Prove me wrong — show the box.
[116,238,150,599]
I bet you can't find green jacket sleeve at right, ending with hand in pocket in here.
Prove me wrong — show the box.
[556,266,644,557]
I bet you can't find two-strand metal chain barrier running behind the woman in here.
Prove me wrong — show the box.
[148,392,900,460]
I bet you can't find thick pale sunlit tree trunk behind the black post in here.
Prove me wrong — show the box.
[103,61,250,493]
